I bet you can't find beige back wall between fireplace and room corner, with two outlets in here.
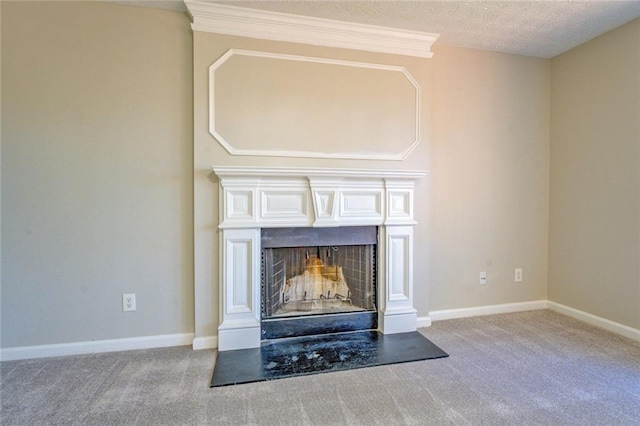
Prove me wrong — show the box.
[428,46,549,311]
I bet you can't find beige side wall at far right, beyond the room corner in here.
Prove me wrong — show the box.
[549,19,640,328]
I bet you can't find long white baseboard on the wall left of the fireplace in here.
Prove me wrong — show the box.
[0,333,194,361]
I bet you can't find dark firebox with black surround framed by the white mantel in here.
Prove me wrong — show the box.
[261,226,378,339]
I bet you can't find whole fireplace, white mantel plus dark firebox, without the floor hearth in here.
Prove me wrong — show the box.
[213,167,425,351]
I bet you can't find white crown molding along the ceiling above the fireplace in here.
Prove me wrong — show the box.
[184,0,439,58]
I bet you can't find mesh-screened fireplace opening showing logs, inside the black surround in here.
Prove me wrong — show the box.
[262,228,376,319]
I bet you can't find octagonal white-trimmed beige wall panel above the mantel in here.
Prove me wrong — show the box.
[209,49,421,161]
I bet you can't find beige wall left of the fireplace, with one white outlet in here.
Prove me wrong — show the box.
[2,2,193,348]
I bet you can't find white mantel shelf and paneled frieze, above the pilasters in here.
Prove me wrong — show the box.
[213,167,426,229]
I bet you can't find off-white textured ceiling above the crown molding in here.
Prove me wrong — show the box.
[124,0,640,58]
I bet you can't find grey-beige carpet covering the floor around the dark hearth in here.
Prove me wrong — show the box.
[0,310,640,426]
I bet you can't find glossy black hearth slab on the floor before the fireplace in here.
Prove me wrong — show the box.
[211,330,449,387]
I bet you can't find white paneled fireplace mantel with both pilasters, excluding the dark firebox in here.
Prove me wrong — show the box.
[213,167,426,351]
